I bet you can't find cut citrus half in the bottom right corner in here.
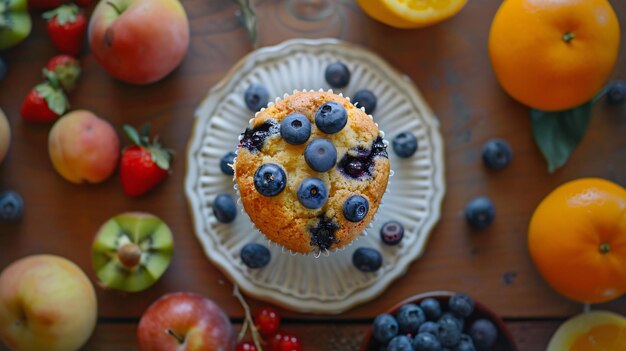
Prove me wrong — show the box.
[546,311,626,351]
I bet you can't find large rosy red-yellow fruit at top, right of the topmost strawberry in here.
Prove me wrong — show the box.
[88,0,189,84]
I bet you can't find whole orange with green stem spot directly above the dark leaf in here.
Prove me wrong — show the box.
[489,0,620,111]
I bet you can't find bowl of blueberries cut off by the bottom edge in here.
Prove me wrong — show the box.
[361,291,517,351]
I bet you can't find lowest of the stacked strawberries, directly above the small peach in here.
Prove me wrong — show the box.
[20,82,68,122]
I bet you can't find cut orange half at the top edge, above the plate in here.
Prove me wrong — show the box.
[357,0,467,28]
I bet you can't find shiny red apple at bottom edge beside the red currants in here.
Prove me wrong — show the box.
[137,292,236,351]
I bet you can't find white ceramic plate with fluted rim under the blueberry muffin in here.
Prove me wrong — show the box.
[185,39,445,314]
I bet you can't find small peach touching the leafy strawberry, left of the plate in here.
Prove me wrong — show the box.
[48,110,120,184]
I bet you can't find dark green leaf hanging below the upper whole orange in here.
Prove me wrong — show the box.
[530,101,593,173]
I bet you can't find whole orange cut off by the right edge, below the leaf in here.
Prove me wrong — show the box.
[528,178,626,303]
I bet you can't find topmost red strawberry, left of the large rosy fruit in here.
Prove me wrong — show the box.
[43,4,87,55]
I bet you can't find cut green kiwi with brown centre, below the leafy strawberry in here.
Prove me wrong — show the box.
[91,212,174,292]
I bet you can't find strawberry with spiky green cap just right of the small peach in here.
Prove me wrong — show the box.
[120,125,173,196]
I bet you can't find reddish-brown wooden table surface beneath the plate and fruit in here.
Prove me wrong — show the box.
[0,0,626,350]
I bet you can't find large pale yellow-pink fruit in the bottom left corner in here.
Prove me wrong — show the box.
[0,255,98,351]
